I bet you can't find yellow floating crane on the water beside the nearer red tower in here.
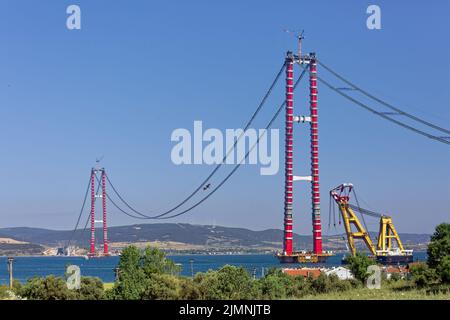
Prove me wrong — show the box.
[330,183,413,264]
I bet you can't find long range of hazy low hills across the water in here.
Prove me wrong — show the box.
[0,223,430,250]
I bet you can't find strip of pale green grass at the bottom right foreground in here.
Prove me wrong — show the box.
[303,281,450,300]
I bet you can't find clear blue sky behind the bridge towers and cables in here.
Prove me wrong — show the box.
[0,0,450,234]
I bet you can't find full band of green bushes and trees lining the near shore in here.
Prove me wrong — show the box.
[0,224,450,300]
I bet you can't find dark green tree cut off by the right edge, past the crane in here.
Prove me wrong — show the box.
[427,223,450,283]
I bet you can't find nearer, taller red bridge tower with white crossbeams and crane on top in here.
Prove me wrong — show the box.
[277,36,332,263]
